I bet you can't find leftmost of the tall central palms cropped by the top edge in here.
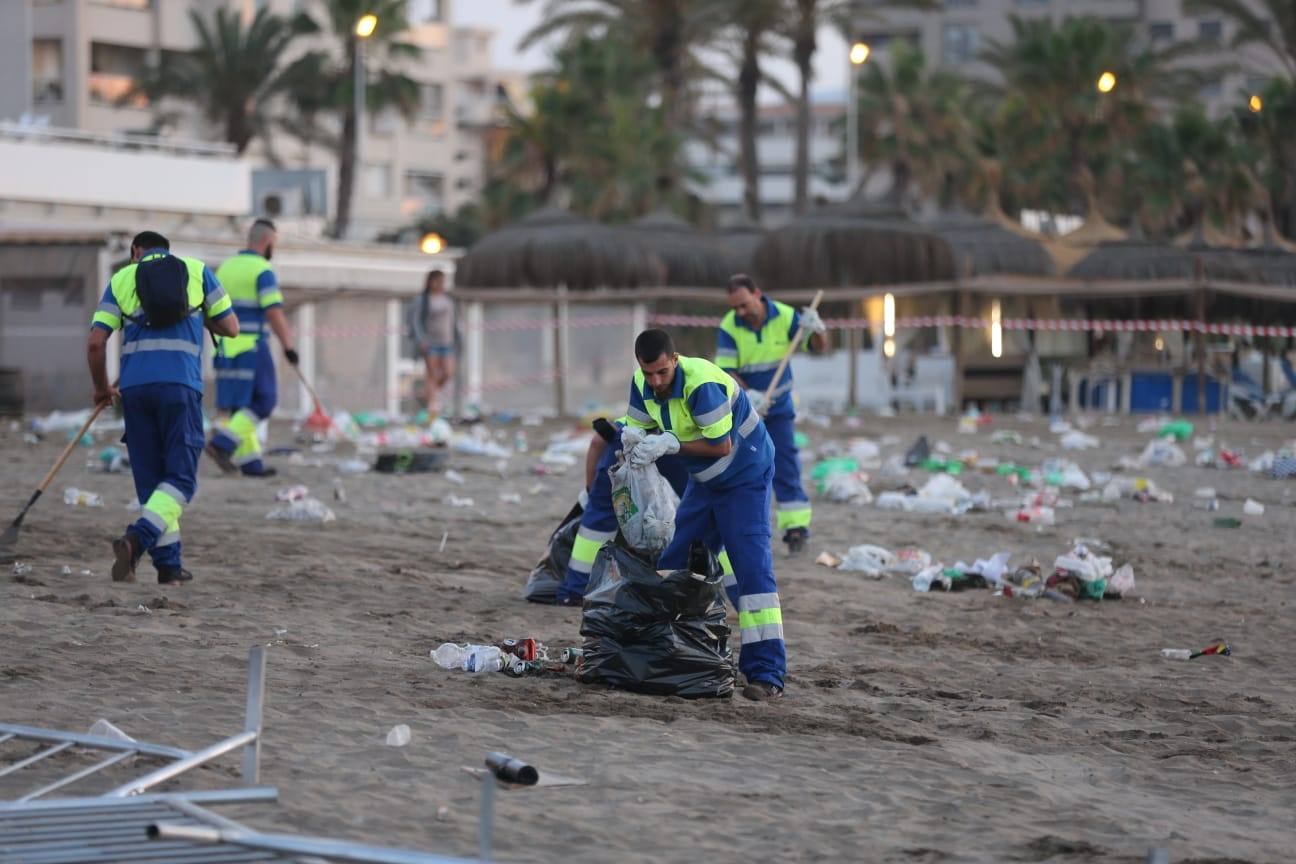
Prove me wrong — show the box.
[518,0,713,196]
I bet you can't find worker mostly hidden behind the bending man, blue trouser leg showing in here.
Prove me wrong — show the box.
[557,417,737,608]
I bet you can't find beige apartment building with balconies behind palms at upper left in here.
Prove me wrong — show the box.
[0,0,518,240]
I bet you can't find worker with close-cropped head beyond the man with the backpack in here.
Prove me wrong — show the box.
[207,219,297,477]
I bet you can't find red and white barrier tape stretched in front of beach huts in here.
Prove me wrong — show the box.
[302,315,1296,339]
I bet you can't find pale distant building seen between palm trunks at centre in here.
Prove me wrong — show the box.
[684,100,846,228]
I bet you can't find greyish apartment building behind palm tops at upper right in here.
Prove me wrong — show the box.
[851,0,1280,115]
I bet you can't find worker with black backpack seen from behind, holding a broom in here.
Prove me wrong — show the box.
[86,231,238,584]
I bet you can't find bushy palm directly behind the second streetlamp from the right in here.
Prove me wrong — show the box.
[985,16,1195,220]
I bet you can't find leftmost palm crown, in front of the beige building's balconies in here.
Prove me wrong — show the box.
[119,8,299,154]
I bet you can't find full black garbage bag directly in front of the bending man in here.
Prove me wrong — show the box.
[578,536,735,699]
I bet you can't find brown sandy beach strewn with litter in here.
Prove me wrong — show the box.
[0,416,1296,864]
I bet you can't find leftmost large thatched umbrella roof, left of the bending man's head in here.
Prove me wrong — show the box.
[455,207,664,290]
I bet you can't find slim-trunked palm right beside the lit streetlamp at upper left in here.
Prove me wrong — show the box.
[285,0,422,238]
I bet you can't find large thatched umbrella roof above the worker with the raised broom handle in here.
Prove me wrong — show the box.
[754,197,954,289]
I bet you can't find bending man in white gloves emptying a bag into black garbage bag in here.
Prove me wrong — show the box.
[622,330,787,701]
